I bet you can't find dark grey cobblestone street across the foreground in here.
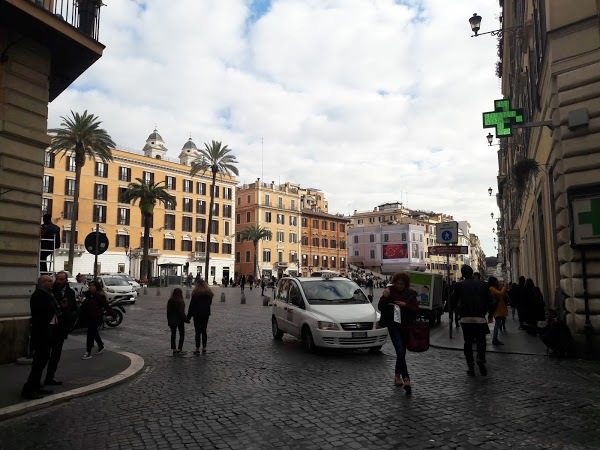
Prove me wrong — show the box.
[0,288,600,449]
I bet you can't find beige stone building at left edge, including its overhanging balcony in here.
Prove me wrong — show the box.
[0,0,104,363]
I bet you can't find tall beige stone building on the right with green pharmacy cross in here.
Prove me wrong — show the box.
[492,0,600,353]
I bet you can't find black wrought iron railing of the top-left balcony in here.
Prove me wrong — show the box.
[29,0,103,41]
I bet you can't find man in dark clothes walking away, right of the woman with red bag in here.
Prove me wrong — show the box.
[452,264,493,376]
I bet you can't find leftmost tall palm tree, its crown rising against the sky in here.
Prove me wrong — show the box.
[48,110,115,273]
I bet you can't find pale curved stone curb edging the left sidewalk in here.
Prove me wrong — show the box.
[0,352,144,421]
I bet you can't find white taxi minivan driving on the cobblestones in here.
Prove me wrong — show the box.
[271,275,388,352]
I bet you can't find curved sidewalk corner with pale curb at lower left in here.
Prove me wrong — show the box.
[0,350,145,421]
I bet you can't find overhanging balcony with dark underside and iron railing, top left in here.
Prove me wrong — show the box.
[0,0,104,101]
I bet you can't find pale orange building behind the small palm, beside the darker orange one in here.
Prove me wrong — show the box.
[235,178,300,278]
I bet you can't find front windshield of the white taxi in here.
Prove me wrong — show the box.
[302,280,369,305]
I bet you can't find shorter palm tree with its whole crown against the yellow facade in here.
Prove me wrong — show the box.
[121,178,177,280]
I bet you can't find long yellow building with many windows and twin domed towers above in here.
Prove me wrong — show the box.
[43,130,236,283]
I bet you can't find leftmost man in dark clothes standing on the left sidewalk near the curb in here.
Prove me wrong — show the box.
[21,275,60,400]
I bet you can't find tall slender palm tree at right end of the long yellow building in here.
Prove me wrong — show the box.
[190,141,239,280]
